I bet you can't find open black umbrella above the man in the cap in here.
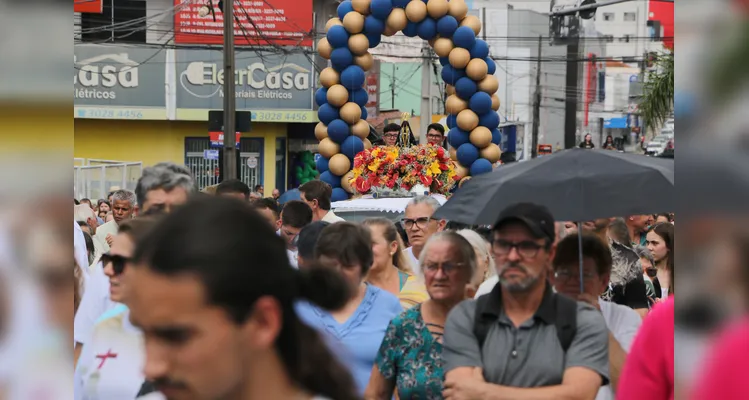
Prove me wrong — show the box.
[435,149,675,225]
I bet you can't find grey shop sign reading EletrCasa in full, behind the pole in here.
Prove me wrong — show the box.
[175,50,315,122]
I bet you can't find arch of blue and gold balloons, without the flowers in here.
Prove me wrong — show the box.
[315,0,501,200]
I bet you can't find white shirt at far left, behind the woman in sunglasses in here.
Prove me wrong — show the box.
[73,263,118,347]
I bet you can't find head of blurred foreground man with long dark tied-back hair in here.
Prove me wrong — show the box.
[126,196,357,400]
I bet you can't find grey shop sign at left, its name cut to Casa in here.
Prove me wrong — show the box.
[73,44,166,119]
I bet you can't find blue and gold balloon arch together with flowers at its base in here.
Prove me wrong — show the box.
[315,0,501,206]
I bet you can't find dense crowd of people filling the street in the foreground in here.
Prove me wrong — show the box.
[73,163,675,400]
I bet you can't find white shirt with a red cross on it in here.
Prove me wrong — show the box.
[73,305,145,400]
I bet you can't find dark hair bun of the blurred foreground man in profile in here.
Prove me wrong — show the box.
[298,265,351,311]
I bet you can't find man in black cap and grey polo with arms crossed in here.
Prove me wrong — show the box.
[443,203,609,400]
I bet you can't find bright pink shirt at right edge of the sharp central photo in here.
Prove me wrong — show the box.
[616,296,676,400]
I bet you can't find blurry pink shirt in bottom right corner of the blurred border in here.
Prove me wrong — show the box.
[694,319,749,399]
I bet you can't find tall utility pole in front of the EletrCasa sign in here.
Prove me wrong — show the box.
[222,0,237,180]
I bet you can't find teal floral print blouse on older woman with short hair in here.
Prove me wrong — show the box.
[375,304,444,400]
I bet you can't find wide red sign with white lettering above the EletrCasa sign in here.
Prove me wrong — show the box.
[174,0,312,46]
